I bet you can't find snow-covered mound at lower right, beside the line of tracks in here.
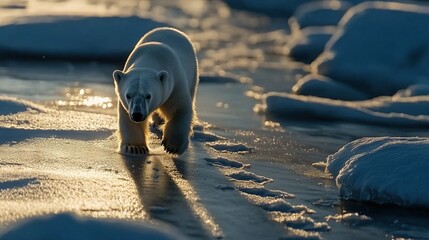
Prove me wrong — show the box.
[326,137,429,207]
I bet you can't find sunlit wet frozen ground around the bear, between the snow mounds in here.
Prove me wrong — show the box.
[0,0,427,239]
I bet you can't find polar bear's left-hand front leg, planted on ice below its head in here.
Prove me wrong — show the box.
[118,104,149,155]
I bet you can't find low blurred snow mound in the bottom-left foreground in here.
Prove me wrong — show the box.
[0,213,185,240]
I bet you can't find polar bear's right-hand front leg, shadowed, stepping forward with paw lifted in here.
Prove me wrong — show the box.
[162,108,193,154]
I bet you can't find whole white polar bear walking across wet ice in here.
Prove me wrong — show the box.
[113,27,199,155]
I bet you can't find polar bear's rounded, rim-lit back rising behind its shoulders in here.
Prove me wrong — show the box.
[136,27,198,93]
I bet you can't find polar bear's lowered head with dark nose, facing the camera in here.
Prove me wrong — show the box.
[113,69,171,122]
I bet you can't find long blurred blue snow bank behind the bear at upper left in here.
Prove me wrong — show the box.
[0,16,166,61]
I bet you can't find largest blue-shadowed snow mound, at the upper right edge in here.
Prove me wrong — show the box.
[312,2,429,97]
